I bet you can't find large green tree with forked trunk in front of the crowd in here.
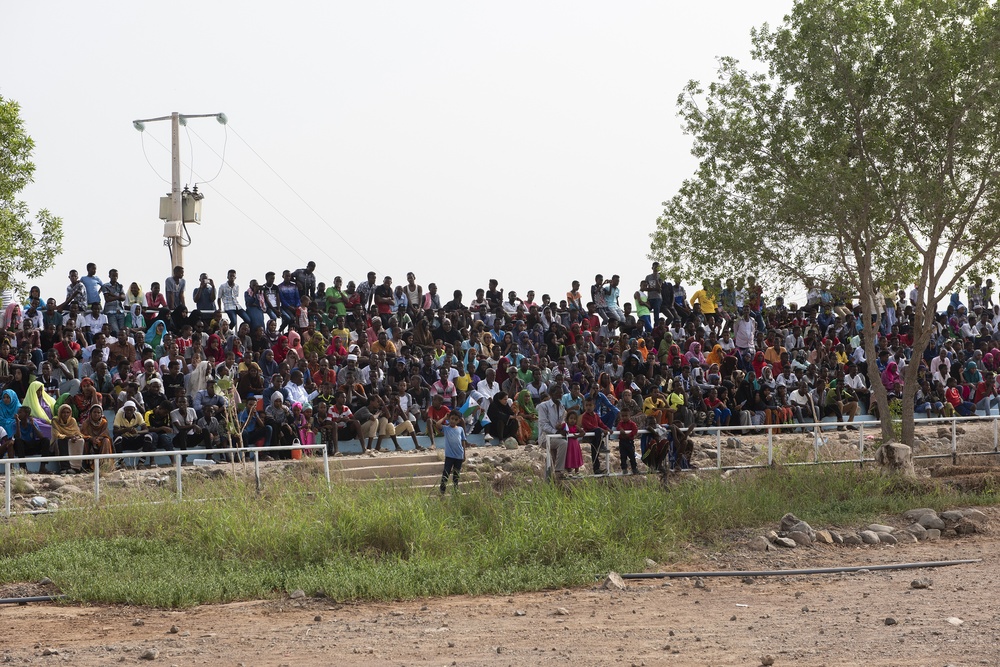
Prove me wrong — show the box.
[650,0,1000,442]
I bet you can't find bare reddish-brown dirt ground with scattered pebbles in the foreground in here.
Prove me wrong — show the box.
[0,509,1000,667]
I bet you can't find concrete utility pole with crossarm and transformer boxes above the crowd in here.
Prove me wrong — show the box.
[132,111,229,272]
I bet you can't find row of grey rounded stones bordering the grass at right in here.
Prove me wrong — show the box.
[750,507,988,551]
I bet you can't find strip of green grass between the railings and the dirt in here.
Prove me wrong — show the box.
[0,466,998,607]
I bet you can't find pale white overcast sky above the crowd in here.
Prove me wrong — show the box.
[0,0,791,302]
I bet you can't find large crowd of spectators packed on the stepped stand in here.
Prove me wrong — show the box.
[0,262,1000,485]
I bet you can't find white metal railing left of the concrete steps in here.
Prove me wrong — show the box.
[0,444,331,518]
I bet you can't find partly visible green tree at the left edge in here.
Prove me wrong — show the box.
[0,96,63,290]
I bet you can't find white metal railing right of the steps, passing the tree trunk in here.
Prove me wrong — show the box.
[545,415,1000,479]
